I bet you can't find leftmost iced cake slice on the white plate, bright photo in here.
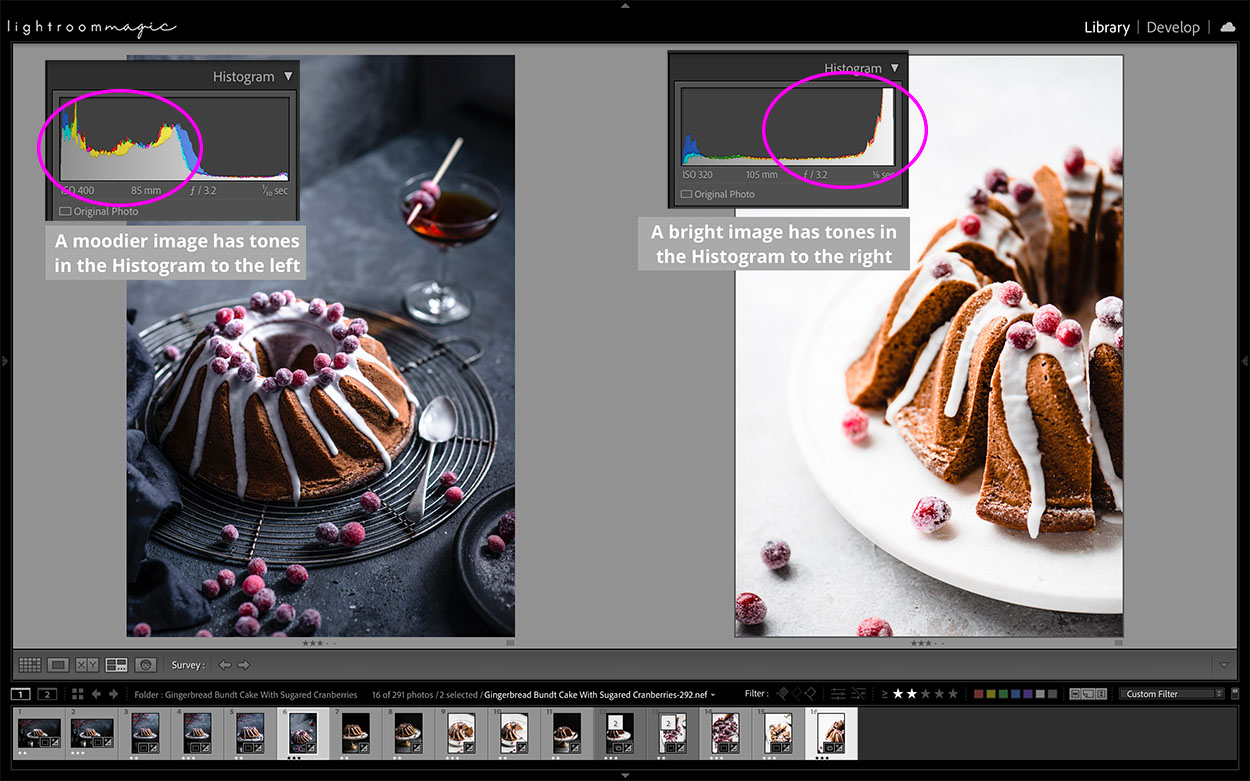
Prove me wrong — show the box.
[846,252,984,407]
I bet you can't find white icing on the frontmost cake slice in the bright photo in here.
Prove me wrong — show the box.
[999,331,1090,539]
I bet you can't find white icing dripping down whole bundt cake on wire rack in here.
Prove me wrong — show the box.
[160,294,418,504]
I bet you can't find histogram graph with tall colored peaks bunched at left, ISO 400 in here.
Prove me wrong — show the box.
[58,95,291,181]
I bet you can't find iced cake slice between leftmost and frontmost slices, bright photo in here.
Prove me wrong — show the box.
[885,282,1033,482]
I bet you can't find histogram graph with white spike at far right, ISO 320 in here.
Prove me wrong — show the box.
[680,85,895,166]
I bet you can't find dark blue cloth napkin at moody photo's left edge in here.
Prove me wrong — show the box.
[126,317,209,632]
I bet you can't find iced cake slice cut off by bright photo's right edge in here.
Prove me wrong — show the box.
[1090,296,1124,511]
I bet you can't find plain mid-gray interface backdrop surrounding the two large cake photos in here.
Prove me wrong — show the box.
[11,44,1240,674]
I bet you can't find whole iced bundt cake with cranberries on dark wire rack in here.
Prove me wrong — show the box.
[155,291,418,504]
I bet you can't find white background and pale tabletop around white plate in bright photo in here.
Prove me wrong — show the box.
[736,57,1123,637]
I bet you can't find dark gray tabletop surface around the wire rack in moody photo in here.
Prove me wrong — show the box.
[126,122,515,637]
